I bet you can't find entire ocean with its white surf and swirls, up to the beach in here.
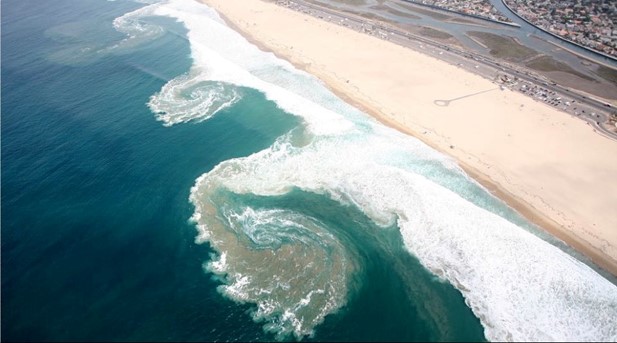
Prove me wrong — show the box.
[1,0,617,341]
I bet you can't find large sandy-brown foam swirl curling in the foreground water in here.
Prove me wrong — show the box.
[192,203,355,339]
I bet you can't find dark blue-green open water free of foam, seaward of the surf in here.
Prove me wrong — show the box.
[2,1,482,341]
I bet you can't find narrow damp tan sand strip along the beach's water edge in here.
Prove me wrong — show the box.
[198,0,617,276]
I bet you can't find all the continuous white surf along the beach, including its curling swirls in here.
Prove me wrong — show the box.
[114,0,617,341]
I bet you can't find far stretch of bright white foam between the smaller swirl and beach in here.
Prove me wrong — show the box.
[149,0,353,135]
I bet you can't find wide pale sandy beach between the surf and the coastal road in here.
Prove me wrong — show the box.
[202,0,617,275]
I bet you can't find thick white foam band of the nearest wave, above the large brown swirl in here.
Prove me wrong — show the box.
[193,135,617,341]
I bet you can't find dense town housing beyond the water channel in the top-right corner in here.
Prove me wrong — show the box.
[505,0,617,57]
